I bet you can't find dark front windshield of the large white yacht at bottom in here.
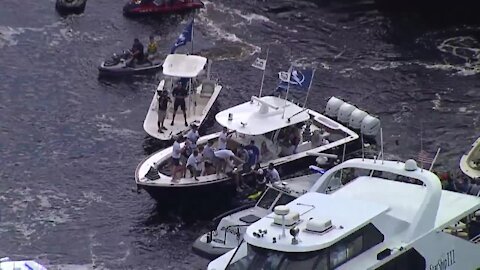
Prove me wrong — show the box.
[226,241,329,270]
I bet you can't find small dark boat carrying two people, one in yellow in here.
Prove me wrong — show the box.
[98,51,163,76]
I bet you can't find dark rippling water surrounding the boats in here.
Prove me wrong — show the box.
[0,0,480,269]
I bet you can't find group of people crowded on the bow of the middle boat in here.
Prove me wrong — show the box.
[171,125,280,192]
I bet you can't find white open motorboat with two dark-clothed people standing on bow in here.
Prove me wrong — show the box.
[143,54,222,141]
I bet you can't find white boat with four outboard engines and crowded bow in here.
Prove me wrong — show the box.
[135,93,380,200]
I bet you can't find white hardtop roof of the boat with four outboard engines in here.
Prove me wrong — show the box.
[215,96,310,135]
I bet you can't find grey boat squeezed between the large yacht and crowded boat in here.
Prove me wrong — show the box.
[192,162,342,260]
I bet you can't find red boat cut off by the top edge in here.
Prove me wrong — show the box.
[123,0,204,16]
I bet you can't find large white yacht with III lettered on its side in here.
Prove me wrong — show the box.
[208,159,480,270]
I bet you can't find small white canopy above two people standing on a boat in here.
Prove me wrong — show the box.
[163,54,207,78]
